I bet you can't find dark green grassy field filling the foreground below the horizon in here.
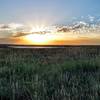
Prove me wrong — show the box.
[0,46,100,100]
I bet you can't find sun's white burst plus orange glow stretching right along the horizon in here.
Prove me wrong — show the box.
[9,25,100,45]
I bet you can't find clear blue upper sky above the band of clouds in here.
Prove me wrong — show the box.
[0,0,100,23]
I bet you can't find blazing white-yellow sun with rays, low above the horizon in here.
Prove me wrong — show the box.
[24,25,55,45]
